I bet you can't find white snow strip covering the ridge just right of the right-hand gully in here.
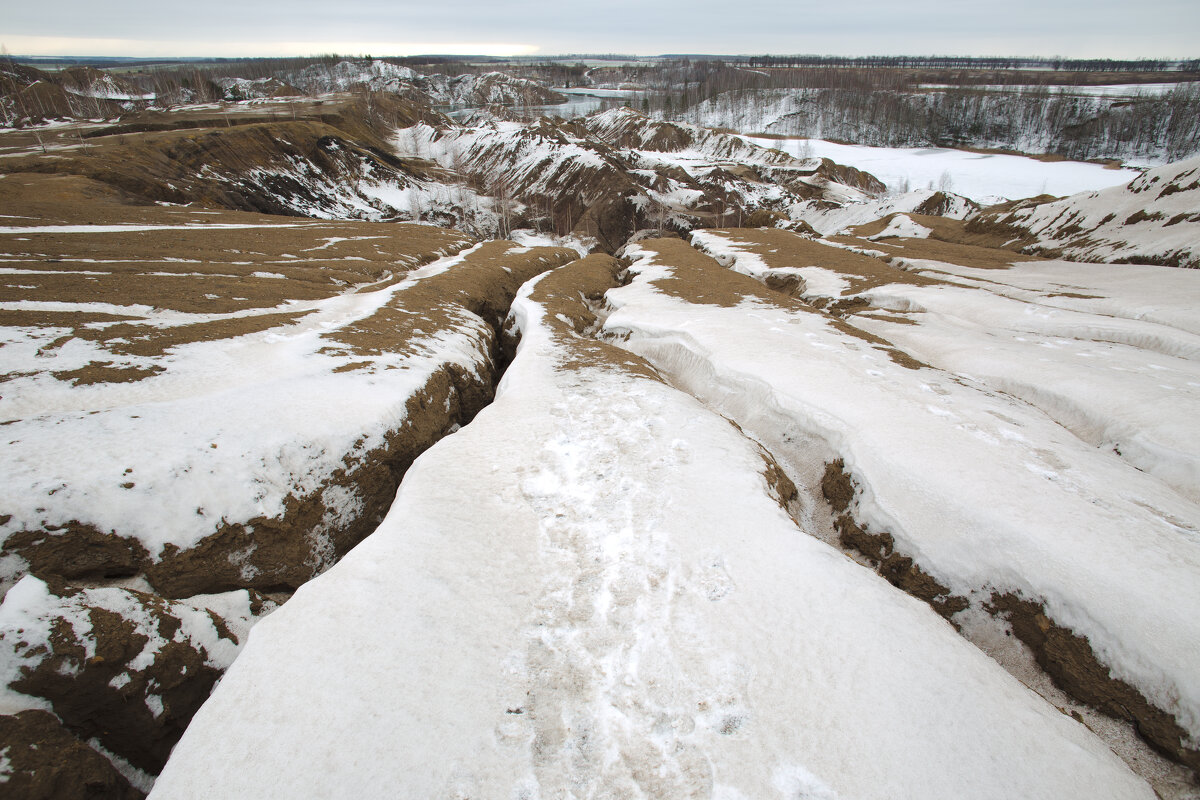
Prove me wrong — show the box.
[605,242,1200,735]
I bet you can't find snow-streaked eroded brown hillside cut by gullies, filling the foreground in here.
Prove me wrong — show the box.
[0,65,1200,800]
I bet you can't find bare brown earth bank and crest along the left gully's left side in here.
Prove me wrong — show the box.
[5,241,576,597]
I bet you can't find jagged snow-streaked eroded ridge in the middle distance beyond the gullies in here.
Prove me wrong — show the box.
[396,109,883,251]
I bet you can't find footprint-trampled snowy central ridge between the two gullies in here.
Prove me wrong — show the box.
[151,257,1154,800]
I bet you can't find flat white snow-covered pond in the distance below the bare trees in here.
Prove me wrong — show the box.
[744,137,1140,205]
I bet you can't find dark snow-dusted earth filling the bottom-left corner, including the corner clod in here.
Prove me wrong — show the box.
[0,577,274,798]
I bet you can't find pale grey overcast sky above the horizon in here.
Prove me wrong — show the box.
[0,0,1200,59]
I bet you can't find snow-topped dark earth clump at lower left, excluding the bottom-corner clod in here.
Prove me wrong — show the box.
[0,576,260,774]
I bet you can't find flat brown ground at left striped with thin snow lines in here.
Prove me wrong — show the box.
[0,174,472,383]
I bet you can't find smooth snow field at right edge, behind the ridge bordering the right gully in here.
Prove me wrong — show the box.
[692,227,1200,501]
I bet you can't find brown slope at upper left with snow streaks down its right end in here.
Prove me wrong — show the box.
[4,95,516,235]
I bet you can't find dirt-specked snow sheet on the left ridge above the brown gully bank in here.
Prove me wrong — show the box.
[0,249,491,555]
